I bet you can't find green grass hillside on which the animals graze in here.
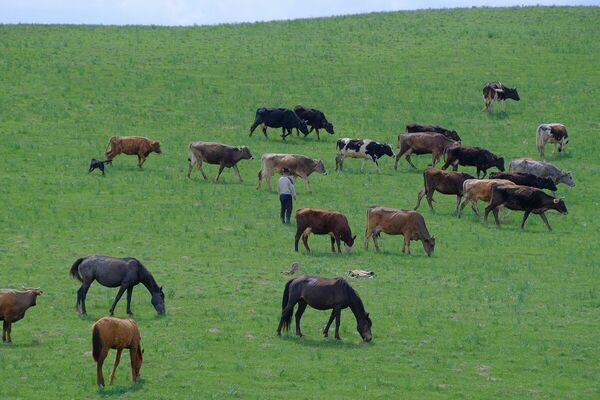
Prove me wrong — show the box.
[0,8,600,399]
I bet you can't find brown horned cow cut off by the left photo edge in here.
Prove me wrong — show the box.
[0,289,43,344]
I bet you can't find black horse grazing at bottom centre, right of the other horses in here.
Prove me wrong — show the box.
[277,275,373,342]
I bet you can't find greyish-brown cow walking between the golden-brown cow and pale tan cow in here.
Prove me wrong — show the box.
[188,142,254,182]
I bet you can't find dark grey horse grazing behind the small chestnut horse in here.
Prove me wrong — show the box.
[71,255,165,316]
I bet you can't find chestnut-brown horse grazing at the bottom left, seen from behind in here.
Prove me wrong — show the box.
[92,317,144,388]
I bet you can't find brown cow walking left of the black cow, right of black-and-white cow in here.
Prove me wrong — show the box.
[394,132,460,170]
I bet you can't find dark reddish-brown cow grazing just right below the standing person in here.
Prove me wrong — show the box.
[294,208,356,254]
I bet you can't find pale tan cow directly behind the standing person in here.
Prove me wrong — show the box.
[256,153,327,192]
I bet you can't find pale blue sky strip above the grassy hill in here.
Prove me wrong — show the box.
[0,0,600,25]
